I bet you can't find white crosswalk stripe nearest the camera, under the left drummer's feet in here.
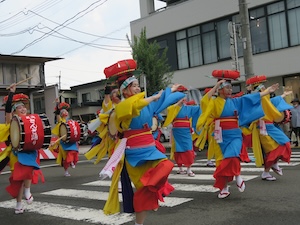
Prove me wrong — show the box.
[0,200,134,225]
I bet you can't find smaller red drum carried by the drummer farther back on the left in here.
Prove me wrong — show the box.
[59,120,84,143]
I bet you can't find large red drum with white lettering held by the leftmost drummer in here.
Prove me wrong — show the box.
[10,114,51,151]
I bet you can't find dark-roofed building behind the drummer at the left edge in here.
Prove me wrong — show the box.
[0,54,60,123]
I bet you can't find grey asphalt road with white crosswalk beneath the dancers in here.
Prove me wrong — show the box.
[0,146,300,225]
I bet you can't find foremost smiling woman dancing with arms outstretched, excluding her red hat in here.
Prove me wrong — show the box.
[100,58,184,225]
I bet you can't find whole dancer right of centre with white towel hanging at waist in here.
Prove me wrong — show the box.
[197,70,279,198]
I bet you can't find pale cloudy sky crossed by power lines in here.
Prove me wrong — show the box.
[0,0,165,89]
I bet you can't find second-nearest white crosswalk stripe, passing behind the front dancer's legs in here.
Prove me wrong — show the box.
[41,189,193,207]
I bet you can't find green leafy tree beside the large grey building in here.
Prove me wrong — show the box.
[128,28,173,96]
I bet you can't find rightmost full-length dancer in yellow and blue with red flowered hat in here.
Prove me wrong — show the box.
[247,75,292,181]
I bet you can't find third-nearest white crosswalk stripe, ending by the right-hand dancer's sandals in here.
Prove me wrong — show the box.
[82,180,218,192]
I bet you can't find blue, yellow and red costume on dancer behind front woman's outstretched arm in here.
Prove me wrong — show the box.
[164,98,201,171]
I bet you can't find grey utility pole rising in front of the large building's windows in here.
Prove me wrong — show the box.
[239,0,254,79]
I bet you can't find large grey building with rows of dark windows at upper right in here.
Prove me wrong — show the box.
[130,0,300,97]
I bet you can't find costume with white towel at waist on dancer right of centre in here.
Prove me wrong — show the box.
[197,70,264,190]
